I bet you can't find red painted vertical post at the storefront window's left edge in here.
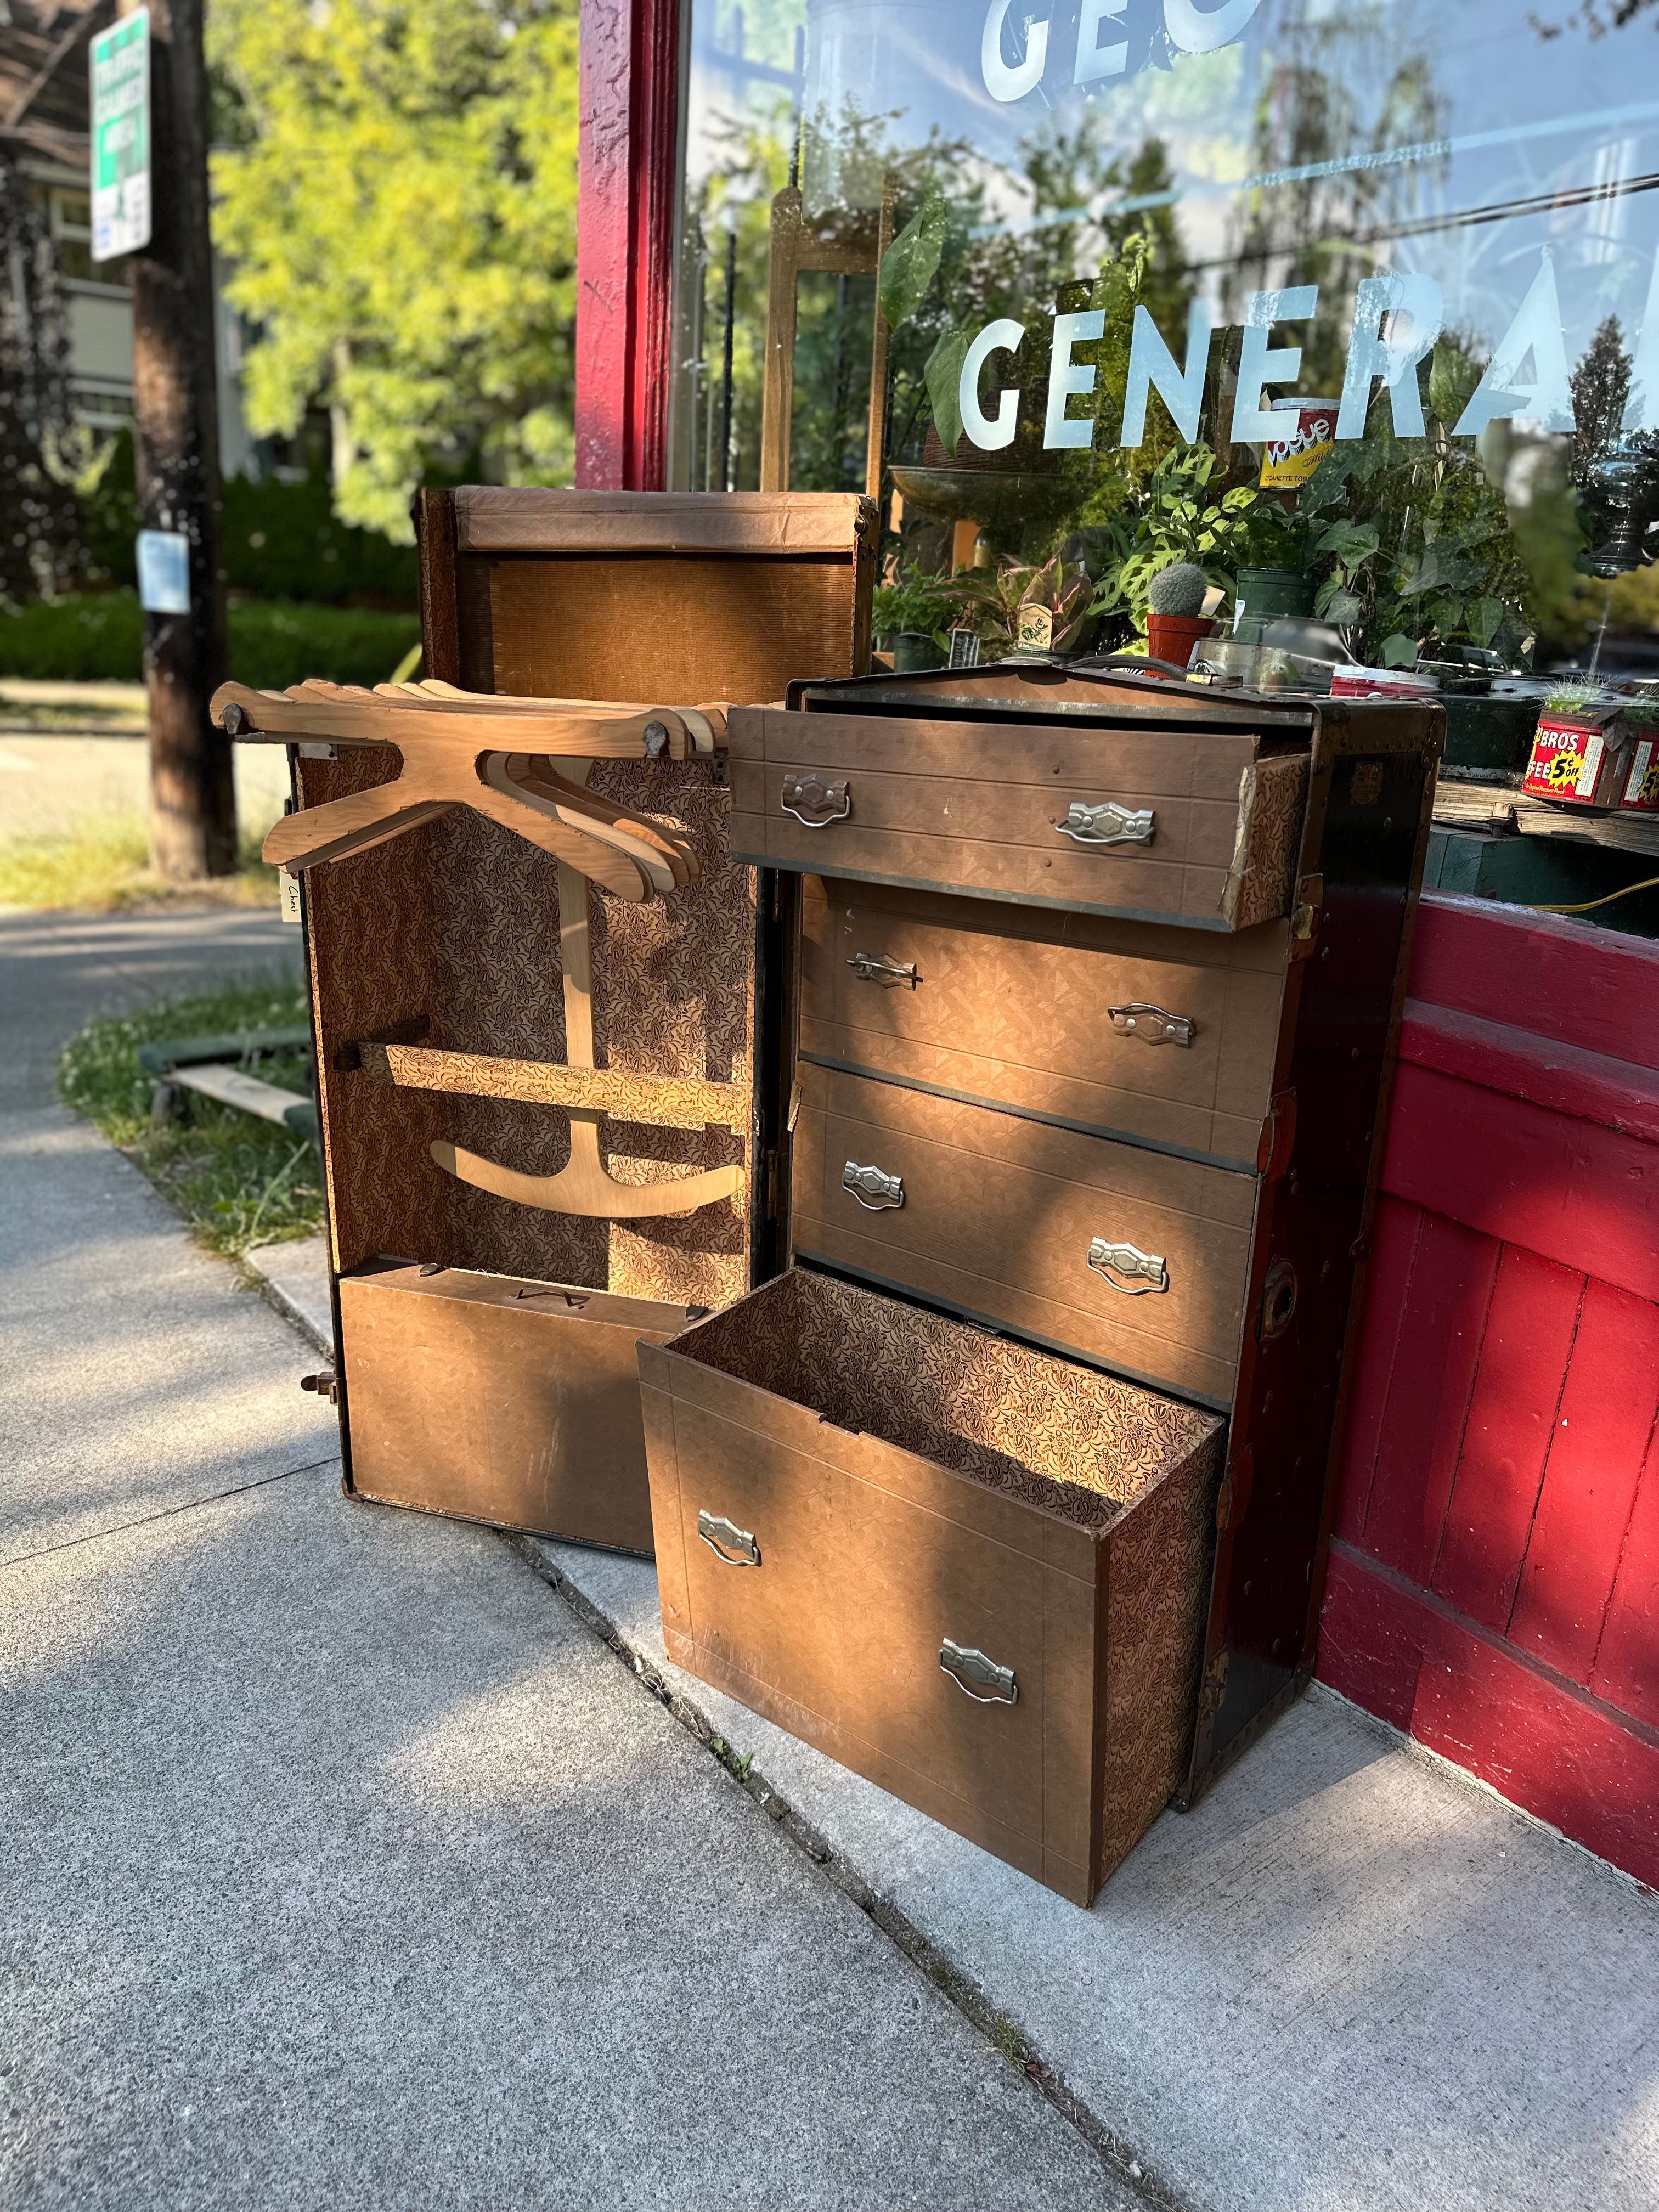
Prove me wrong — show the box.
[575,0,679,491]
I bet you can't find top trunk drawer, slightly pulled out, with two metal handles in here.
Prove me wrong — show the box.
[730,708,1307,929]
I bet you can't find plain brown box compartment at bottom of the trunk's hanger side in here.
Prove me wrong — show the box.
[341,1263,697,1555]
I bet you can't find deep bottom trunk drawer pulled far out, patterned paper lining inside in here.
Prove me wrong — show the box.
[639,1269,1223,1905]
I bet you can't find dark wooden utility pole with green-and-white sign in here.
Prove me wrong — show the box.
[120,0,236,883]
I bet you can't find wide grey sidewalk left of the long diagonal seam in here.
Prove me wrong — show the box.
[0,913,1132,2212]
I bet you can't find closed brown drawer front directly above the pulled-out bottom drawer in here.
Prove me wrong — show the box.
[794,1066,1256,1400]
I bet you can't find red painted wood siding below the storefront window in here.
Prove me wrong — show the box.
[1318,898,1659,1884]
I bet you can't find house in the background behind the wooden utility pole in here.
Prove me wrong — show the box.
[0,0,258,478]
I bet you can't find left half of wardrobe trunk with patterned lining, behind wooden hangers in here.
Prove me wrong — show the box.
[285,489,874,1550]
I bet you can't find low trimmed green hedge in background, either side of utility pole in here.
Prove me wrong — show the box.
[0,591,420,690]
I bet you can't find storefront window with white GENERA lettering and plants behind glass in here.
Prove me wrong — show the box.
[673,0,1659,681]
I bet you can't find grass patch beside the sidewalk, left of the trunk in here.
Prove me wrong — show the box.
[58,978,323,1259]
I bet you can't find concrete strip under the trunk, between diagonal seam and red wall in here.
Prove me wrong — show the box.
[257,1239,1659,2212]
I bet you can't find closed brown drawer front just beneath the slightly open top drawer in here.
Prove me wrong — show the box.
[801,885,1285,1166]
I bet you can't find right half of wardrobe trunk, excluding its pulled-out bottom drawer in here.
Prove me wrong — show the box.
[690,664,1442,1867]
